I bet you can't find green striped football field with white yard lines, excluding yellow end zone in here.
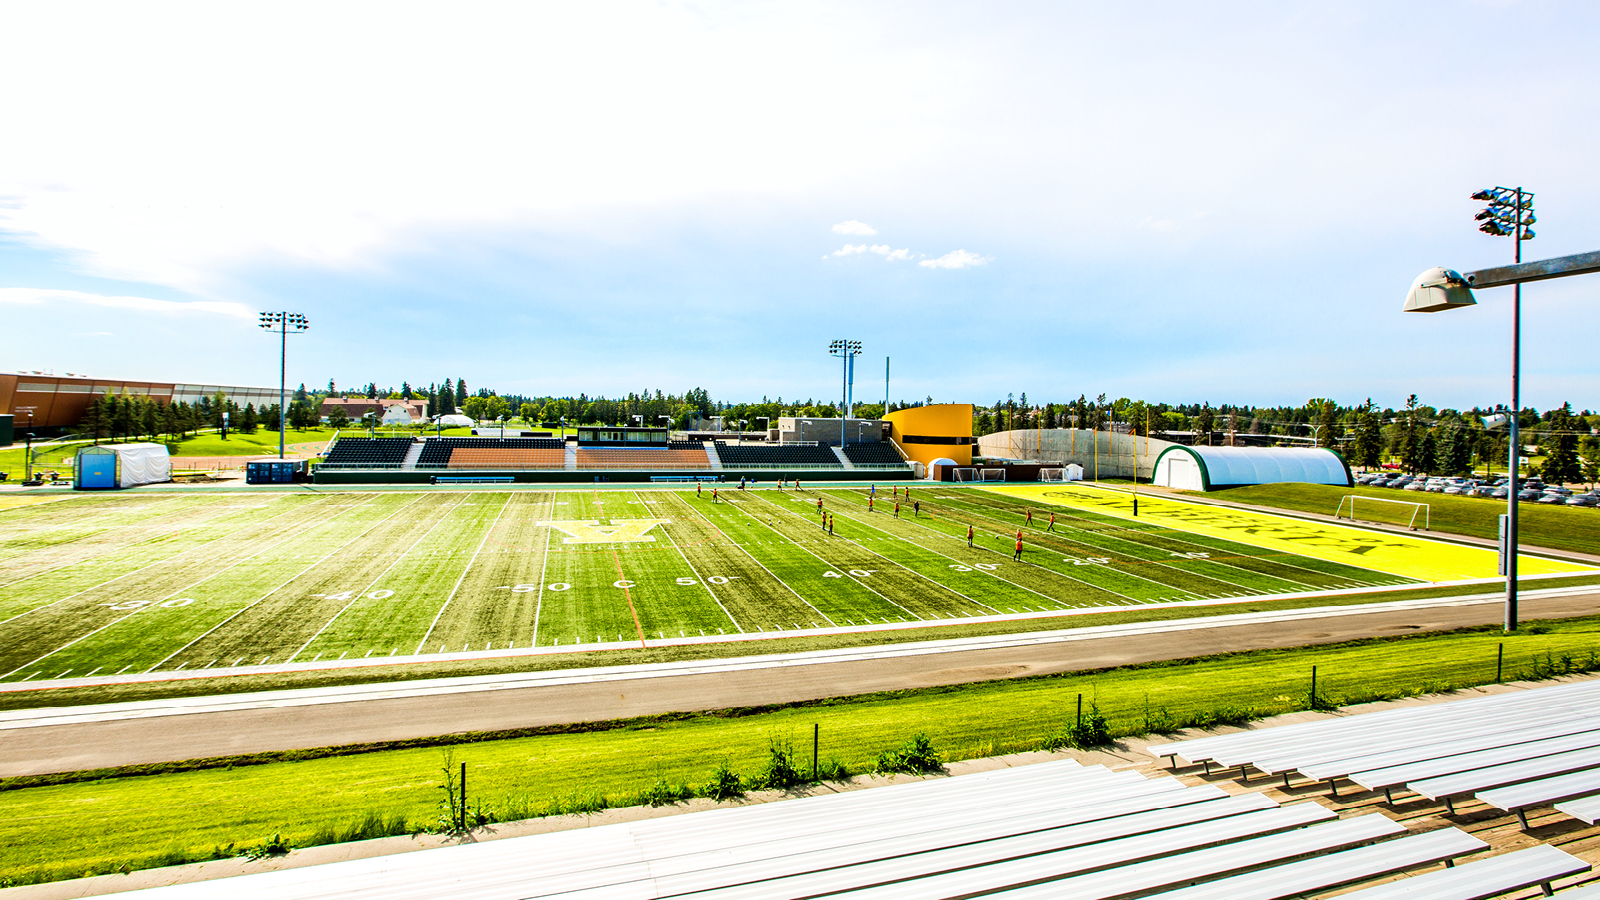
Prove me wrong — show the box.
[0,485,1440,681]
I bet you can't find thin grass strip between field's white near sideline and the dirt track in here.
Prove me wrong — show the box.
[0,575,1600,709]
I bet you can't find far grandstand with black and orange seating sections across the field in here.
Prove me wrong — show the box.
[323,437,906,471]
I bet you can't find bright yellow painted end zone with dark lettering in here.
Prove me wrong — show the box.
[981,485,1595,581]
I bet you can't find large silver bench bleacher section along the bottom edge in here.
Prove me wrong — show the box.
[106,761,1590,900]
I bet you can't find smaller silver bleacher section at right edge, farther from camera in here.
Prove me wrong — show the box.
[1150,681,1600,828]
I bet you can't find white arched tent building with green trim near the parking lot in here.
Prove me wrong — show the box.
[1150,444,1354,490]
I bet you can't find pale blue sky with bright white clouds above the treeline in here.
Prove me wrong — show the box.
[0,0,1600,408]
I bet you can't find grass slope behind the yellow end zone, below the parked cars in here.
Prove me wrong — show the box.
[1211,484,1600,554]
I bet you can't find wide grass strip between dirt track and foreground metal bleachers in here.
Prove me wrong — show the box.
[0,617,1600,884]
